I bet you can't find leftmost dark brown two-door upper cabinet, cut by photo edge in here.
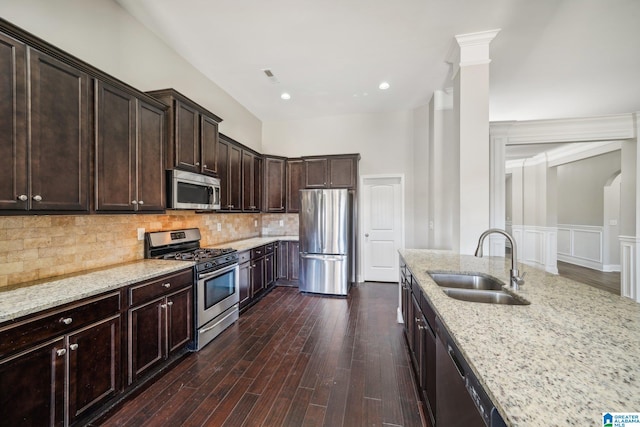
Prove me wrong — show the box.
[0,29,90,211]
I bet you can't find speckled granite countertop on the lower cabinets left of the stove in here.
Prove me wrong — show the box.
[0,259,194,323]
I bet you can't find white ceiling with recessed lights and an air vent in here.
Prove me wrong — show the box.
[116,0,640,121]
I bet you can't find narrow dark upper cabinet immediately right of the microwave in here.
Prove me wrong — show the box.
[217,134,242,211]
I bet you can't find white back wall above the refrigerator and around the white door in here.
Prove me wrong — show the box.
[262,111,418,247]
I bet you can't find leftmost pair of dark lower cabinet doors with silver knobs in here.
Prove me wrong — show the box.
[0,315,121,426]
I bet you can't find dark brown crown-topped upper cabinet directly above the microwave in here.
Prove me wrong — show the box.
[147,89,222,176]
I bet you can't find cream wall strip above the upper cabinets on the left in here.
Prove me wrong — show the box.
[0,0,262,150]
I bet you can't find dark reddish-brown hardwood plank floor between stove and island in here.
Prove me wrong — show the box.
[97,283,422,427]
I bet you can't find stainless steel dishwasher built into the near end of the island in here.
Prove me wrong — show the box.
[436,318,506,427]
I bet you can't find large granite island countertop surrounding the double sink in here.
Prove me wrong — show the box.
[400,249,640,426]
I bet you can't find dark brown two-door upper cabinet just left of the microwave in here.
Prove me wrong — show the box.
[95,81,166,212]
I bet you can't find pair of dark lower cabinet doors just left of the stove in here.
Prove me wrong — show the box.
[128,286,193,384]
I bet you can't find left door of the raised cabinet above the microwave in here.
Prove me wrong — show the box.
[175,100,200,172]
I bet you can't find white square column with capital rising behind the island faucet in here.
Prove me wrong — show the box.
[451,30,500,254]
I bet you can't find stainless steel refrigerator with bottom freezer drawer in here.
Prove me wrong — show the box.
[299,190,353,295]
